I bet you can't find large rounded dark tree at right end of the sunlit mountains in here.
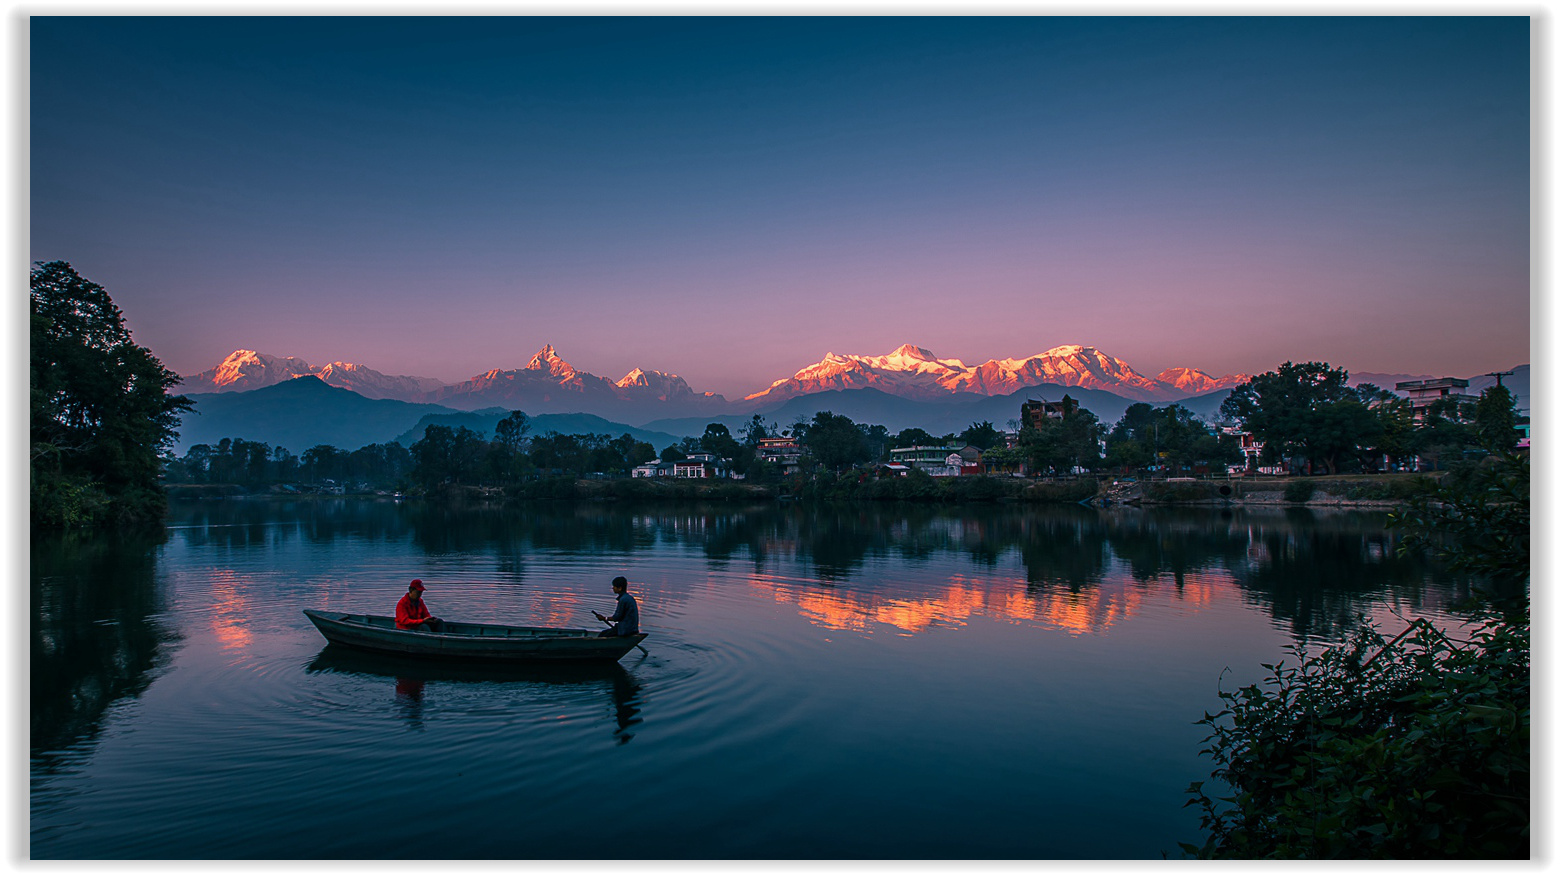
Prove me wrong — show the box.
[1220,362,1382,474]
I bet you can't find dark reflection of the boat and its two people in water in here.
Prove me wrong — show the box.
[304,645,644,745]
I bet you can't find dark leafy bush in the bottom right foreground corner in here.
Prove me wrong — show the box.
[1182,607,1530,859]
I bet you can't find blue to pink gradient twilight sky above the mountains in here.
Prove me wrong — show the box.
[27,16,1530,397]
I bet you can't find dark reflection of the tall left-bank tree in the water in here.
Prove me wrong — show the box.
[31,536,173,770]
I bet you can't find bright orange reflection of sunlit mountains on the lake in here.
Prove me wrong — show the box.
[750,575,1232,634]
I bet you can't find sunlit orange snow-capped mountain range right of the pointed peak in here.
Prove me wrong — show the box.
[746,344,1250,402]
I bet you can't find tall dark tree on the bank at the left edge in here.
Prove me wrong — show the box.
[28,262,190,530]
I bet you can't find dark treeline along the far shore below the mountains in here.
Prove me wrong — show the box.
[165,356,1516,500]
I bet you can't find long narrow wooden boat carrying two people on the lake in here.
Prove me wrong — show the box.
[304,609,646,662]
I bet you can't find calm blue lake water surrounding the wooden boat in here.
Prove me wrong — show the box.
[31,500,1462,859]
